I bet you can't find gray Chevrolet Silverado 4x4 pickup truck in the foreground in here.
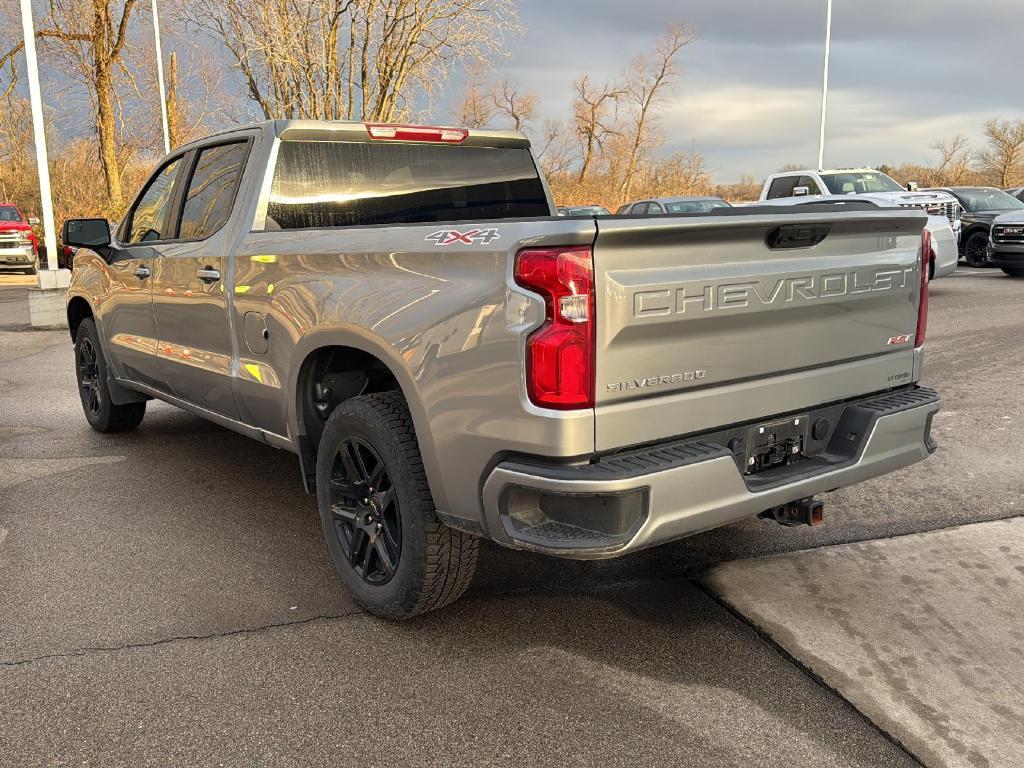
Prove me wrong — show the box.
[63,121,939,617]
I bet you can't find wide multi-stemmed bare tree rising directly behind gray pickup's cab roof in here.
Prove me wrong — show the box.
[180,0,519,122]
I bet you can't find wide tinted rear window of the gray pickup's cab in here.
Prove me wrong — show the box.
[266,141,551,229]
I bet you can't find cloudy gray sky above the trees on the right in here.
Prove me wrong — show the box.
[497,0,1024,181]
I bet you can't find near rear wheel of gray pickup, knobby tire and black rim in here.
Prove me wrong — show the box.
[316,392,479,618]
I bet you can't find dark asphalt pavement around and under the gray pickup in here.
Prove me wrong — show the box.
[0,269,1024,767]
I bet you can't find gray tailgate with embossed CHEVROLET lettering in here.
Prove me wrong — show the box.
[594,209,927,450]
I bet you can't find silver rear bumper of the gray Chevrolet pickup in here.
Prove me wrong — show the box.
[483,387,939,559]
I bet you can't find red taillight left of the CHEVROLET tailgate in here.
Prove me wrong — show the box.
[515,246,595,410]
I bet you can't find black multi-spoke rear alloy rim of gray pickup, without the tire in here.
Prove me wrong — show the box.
[330,437,401,586]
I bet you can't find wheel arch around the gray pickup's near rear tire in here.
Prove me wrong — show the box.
[288,327,443,508]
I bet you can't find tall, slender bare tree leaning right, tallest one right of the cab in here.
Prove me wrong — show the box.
[620,24,694,200]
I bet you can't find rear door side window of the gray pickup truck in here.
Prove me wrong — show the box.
[178,143,246,240]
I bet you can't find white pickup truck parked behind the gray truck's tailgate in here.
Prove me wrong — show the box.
[759,168,964,280]
